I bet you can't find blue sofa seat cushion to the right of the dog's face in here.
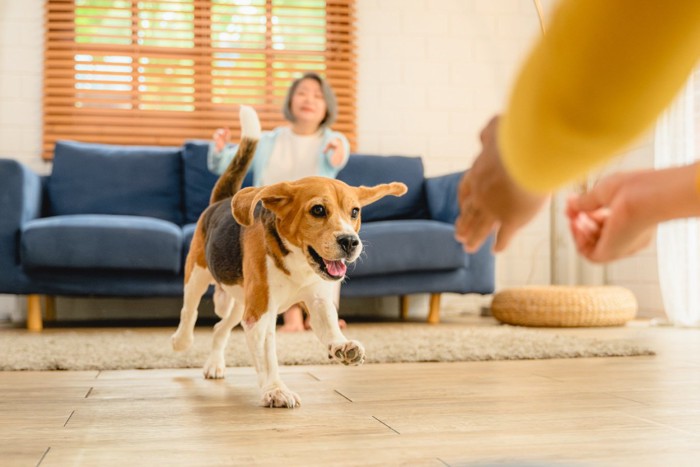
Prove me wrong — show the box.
[348,220,468,278]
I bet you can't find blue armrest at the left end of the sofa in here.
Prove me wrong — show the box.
[0,159,43,293]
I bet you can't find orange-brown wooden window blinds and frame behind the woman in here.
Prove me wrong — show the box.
[42,0,357,160]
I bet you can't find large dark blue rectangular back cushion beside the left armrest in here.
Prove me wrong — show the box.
[48,141,183,224]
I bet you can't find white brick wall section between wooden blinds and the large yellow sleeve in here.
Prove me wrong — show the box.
[357,0,550,288]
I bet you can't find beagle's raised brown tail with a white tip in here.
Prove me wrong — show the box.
[209,105,261,204]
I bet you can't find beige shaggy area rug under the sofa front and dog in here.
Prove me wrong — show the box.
[0,323,654,370]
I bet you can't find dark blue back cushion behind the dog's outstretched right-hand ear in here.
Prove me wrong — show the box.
[338,154,428,222]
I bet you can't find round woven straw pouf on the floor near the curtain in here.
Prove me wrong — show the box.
[491,285,637,327]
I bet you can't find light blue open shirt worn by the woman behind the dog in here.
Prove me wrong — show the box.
[207,128,350,186]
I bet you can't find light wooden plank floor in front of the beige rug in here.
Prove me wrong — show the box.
[0,318,700,466]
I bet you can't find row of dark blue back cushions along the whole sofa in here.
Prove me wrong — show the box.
[47,141,428,225]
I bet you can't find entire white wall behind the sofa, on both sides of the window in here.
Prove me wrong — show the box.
[0,0,661,315]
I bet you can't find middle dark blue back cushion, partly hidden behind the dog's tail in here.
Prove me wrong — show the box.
[182,141,253,223]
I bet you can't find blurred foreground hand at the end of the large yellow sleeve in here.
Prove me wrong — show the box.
[455,117,548,252]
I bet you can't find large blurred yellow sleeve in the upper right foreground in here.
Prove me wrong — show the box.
[498,0,700,193]
